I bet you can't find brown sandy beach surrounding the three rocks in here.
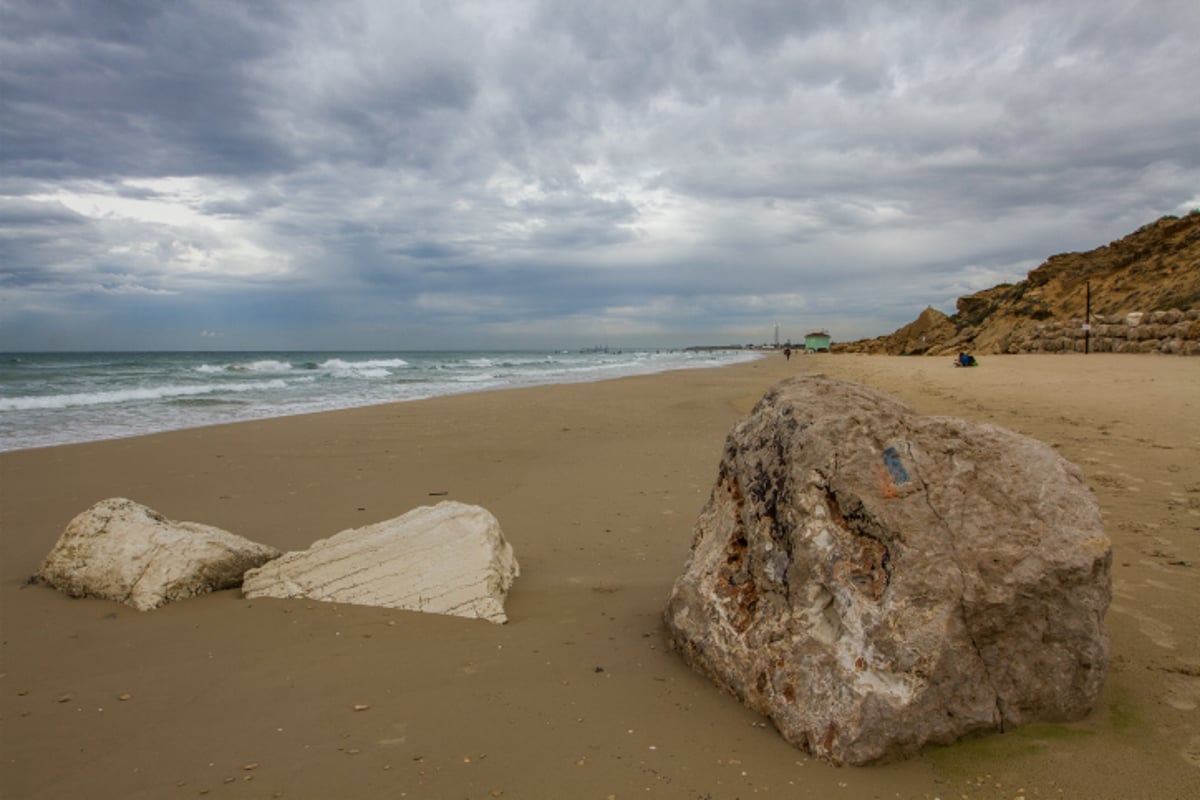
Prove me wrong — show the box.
[0,355,1200,800]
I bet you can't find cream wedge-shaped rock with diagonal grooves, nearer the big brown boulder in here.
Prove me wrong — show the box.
[242,501,520,622]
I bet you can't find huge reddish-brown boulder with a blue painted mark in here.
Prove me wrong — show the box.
[665,375,1111,764]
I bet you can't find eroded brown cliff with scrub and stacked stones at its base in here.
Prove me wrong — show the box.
[834,211,1200,355]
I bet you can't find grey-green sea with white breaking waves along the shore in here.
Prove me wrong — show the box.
[0,348,757,451]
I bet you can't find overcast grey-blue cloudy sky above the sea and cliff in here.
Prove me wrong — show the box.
[0,0,1200,350]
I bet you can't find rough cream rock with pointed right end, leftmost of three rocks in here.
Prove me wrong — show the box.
[34,498,280,610]
